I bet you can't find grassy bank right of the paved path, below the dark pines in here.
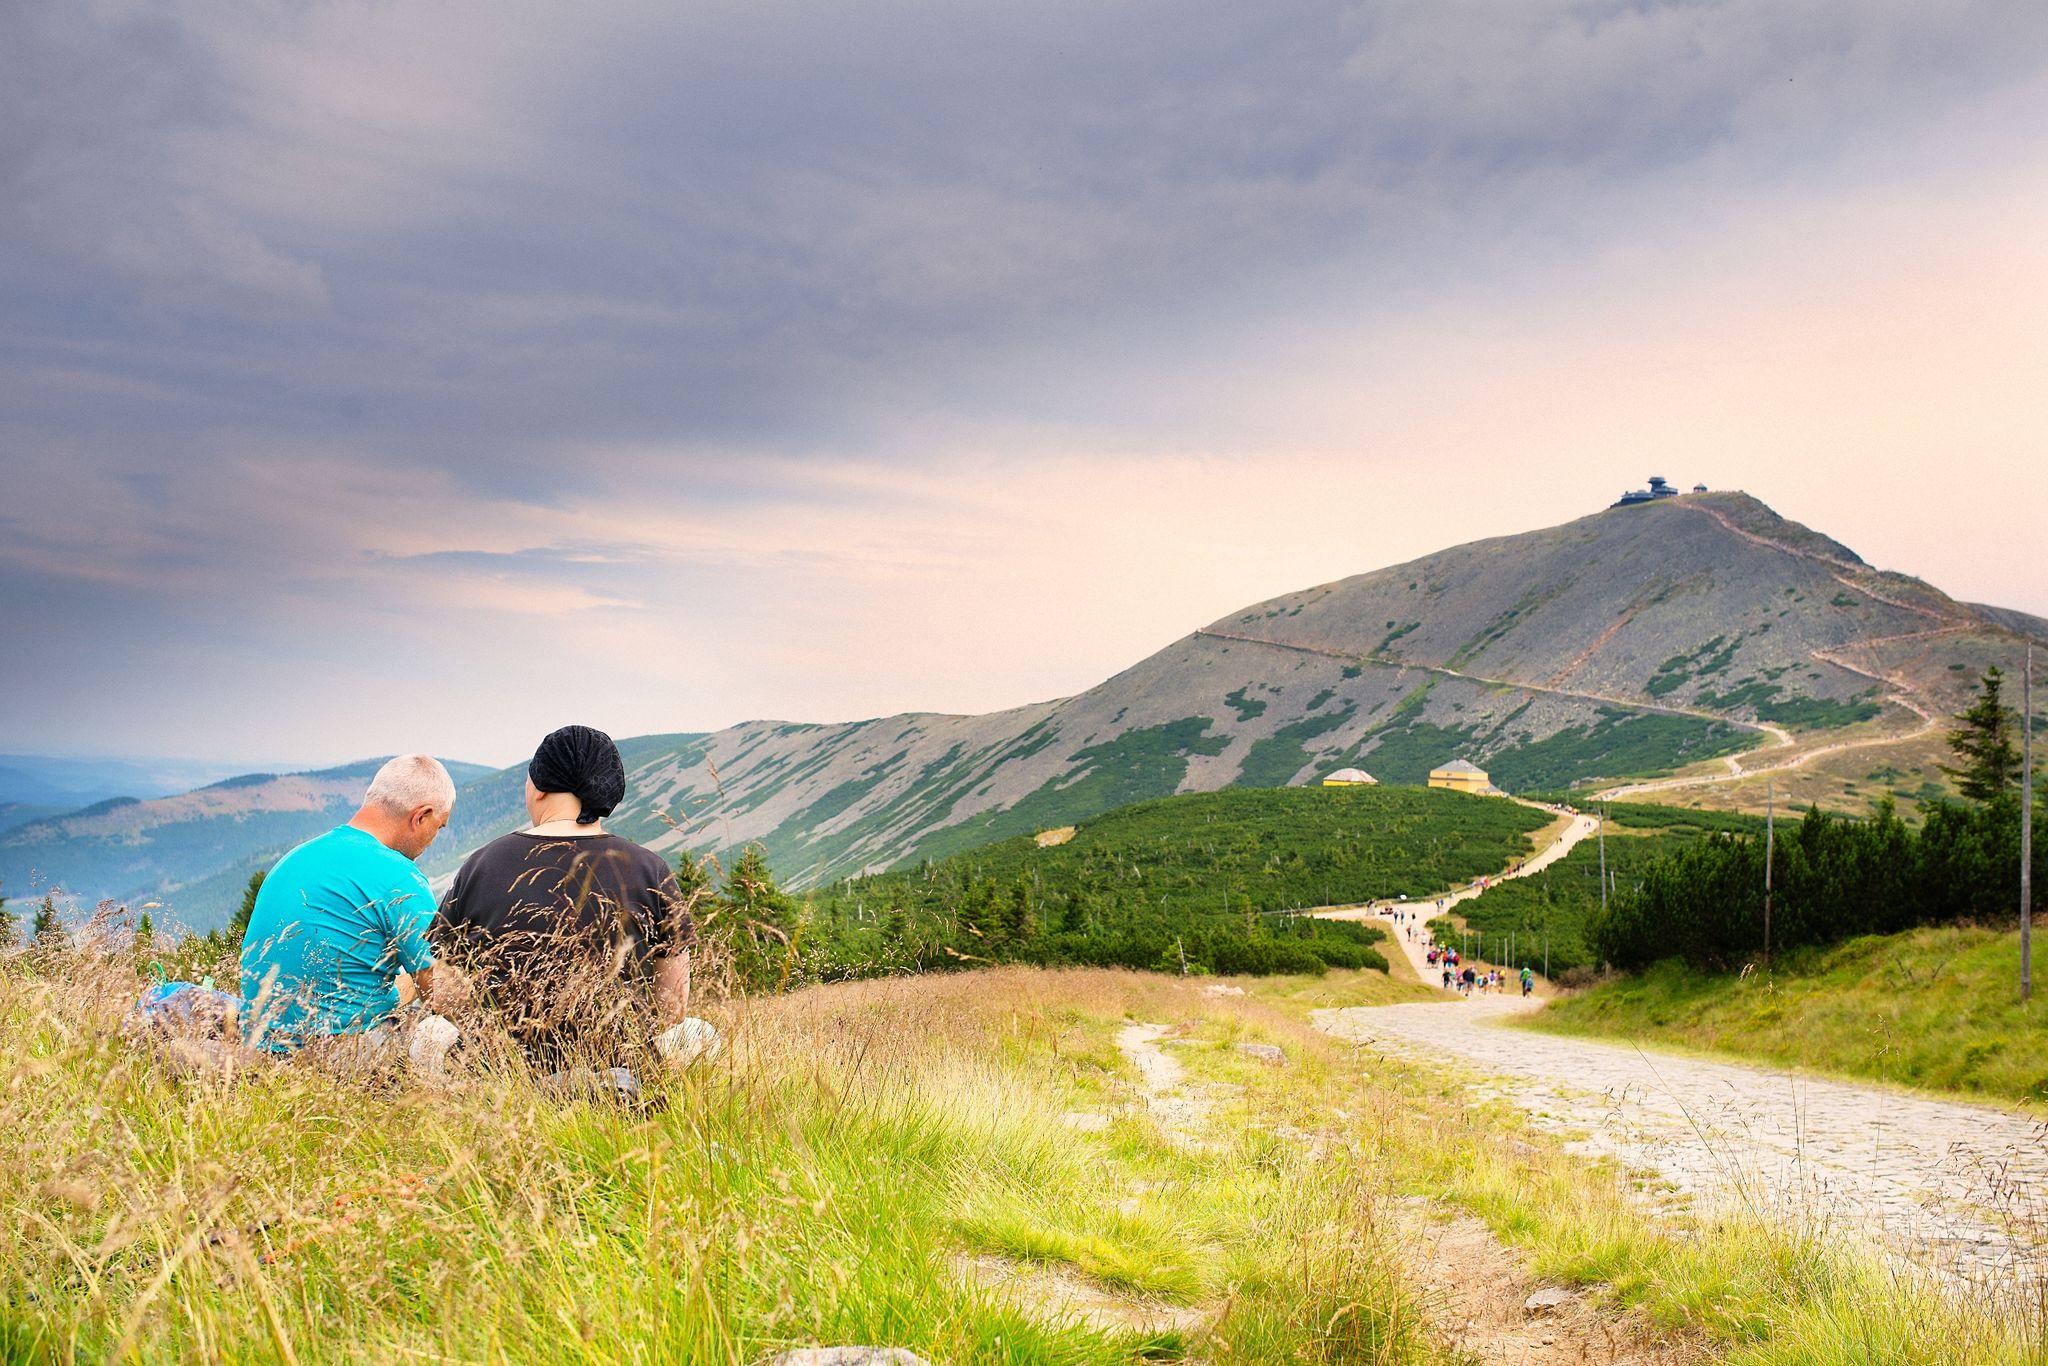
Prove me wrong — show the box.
[1534,925,2048,1102]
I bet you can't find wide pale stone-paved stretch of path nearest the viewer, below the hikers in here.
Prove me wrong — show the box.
[1315,997,2048,1296]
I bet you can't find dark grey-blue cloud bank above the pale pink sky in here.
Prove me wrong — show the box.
[0,0,2048,757]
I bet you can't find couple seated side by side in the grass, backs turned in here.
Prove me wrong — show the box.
[242,725,709,1071]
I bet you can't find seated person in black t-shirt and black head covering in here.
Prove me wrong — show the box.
[434,725,694,1071]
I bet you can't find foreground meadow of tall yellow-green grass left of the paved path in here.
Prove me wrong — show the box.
[0,961,2038,1366]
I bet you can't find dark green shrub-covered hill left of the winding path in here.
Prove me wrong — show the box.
[809,786,1544,975]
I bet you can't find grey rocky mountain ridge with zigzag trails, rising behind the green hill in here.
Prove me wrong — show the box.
[0,494,2048,924]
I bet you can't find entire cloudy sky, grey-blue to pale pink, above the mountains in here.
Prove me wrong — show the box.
[0,0,2048,764]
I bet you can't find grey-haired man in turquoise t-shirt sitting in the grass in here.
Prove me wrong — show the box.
[242,754,455,1053]
